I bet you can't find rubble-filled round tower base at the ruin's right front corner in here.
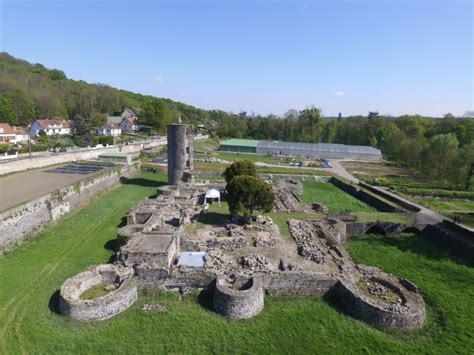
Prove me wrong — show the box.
[335,266,425,331]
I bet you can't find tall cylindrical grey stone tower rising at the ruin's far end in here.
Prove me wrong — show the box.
[167,123,194,185]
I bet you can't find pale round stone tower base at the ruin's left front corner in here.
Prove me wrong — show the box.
[59,264,138,321]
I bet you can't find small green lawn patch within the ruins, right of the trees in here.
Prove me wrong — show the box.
[301,182,376,212]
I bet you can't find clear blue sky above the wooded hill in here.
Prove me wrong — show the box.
[0,0,474,116]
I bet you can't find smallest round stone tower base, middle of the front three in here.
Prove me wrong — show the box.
[214,276,263,319]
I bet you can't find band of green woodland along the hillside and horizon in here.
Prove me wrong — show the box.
[0,53,474,189]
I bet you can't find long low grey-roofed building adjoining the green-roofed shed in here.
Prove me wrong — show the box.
[257,141,382,161]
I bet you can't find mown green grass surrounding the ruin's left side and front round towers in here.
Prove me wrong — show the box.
[0,173,474,354]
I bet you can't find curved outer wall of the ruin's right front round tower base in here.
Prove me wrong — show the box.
[331,270,425,331]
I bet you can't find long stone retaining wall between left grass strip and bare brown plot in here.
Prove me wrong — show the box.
[0,164,139,254]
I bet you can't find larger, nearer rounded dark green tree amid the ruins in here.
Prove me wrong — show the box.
[227,175,275,217]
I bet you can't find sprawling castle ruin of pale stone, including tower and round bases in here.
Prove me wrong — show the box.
[59,125,425,331]
